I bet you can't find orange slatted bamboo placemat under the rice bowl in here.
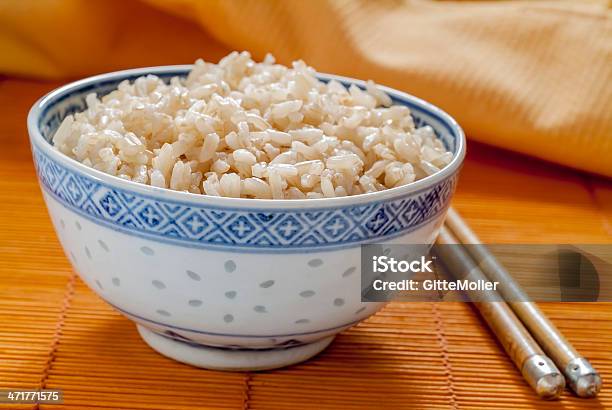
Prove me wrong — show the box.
[0,79,612,409]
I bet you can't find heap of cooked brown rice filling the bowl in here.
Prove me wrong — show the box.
[53,52,452,199]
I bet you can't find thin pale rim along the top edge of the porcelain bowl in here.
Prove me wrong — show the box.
[27,64,466,210]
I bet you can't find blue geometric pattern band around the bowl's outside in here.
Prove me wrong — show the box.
[32,145,456,252]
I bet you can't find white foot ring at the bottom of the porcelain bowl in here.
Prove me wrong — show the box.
[136,325,335,371]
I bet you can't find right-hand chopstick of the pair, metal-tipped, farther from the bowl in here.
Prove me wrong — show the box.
[446,208,602,397]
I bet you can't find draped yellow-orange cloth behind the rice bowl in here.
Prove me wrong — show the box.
[0,0,612,176]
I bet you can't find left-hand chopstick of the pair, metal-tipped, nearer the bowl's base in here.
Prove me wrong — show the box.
[436,227,565,399]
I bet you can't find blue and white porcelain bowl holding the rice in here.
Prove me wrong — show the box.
[28,65,465,370]
